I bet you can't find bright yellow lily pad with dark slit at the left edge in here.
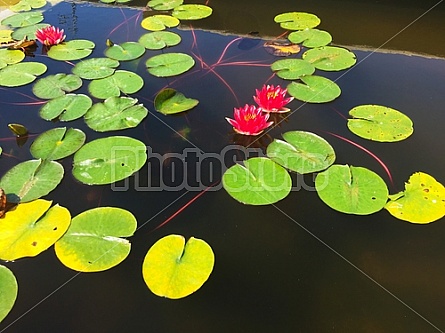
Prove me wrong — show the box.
[0,199,71,260]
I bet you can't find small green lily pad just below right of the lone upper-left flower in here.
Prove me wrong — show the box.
[48,39,95,61]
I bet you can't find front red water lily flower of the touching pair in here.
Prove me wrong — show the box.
[226,104,273,135]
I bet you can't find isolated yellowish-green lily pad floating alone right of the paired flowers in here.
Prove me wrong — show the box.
[348,105,414,142]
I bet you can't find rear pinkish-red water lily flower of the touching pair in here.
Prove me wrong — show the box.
[253,85,294,112]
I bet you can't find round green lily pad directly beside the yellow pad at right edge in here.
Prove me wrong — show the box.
[315,164,388,215]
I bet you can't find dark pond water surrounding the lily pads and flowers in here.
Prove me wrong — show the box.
[0,0,445,332]
